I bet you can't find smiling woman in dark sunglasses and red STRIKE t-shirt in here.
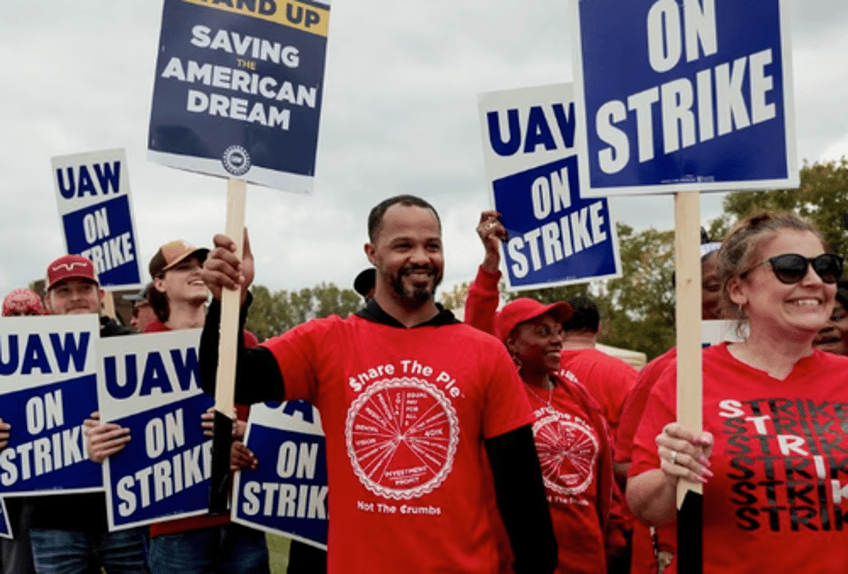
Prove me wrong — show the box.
[627,213,848,574]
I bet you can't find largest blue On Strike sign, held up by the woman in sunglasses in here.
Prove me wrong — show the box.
[572,0,799,197]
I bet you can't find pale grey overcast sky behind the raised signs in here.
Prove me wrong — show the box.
[0,0,848,304]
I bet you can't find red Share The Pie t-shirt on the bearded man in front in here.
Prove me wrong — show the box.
[262,315,533,574]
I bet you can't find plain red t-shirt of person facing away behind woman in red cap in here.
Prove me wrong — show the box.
[559,348,638,440]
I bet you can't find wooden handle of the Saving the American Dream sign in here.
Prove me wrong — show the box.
[209,178,247,514]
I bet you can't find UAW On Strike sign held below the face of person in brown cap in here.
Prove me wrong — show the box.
[97,329,213,530]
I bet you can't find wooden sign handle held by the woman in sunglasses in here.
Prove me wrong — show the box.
[674,191,704,574]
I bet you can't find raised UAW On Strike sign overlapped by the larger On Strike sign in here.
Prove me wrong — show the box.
[479,84,621,290]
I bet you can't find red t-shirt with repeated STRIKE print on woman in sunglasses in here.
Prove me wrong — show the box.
[630,343,848,574]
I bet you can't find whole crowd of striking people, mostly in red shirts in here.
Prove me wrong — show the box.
[0,195,848,574]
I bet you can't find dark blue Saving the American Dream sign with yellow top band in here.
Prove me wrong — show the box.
[148,0,330,193]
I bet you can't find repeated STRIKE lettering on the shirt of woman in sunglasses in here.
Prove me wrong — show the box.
[718,398,848,532]
